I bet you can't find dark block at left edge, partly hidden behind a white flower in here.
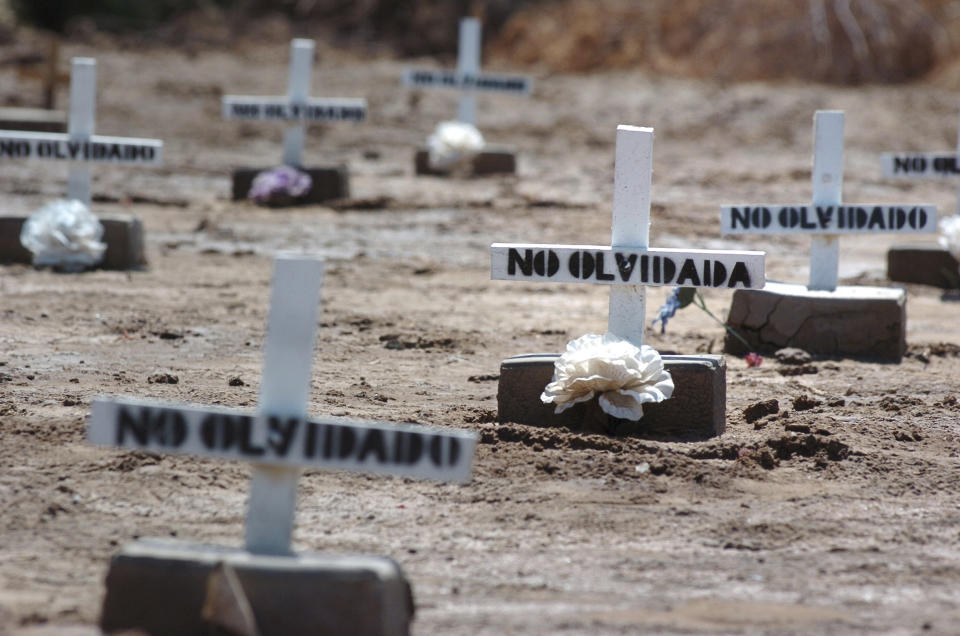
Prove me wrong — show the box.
[0,215,147,270]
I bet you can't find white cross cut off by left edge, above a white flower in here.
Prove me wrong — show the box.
[0,57,163,206]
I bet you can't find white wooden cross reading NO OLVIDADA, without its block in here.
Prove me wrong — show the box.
[490,125,764,346]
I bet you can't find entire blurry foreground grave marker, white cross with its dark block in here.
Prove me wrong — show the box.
[94,257,477,634]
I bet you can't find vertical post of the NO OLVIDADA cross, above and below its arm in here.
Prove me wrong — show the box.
[607,125,653,347]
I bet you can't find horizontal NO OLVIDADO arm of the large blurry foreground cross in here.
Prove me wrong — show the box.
[87,398,477,483]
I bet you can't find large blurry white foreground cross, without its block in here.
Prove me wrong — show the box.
[87,257,477,554]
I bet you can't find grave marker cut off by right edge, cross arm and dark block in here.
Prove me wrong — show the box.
[880,109,960,289]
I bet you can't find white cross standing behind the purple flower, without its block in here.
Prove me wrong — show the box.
[222,38,367,168]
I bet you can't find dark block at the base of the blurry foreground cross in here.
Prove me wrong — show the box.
[100,540,414,636]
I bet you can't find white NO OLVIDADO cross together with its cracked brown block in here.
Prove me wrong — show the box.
[720,111,937,362]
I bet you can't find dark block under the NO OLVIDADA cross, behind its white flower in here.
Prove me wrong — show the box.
[497,354,727,441]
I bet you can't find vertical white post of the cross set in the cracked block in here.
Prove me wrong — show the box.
[808,110,843,291]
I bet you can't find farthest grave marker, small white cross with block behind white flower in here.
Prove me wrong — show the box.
[403,18,533,176]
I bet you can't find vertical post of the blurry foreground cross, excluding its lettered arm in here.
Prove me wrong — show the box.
[246,257,323,554]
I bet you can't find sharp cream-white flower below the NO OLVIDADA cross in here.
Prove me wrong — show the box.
[540,333,673,421]
